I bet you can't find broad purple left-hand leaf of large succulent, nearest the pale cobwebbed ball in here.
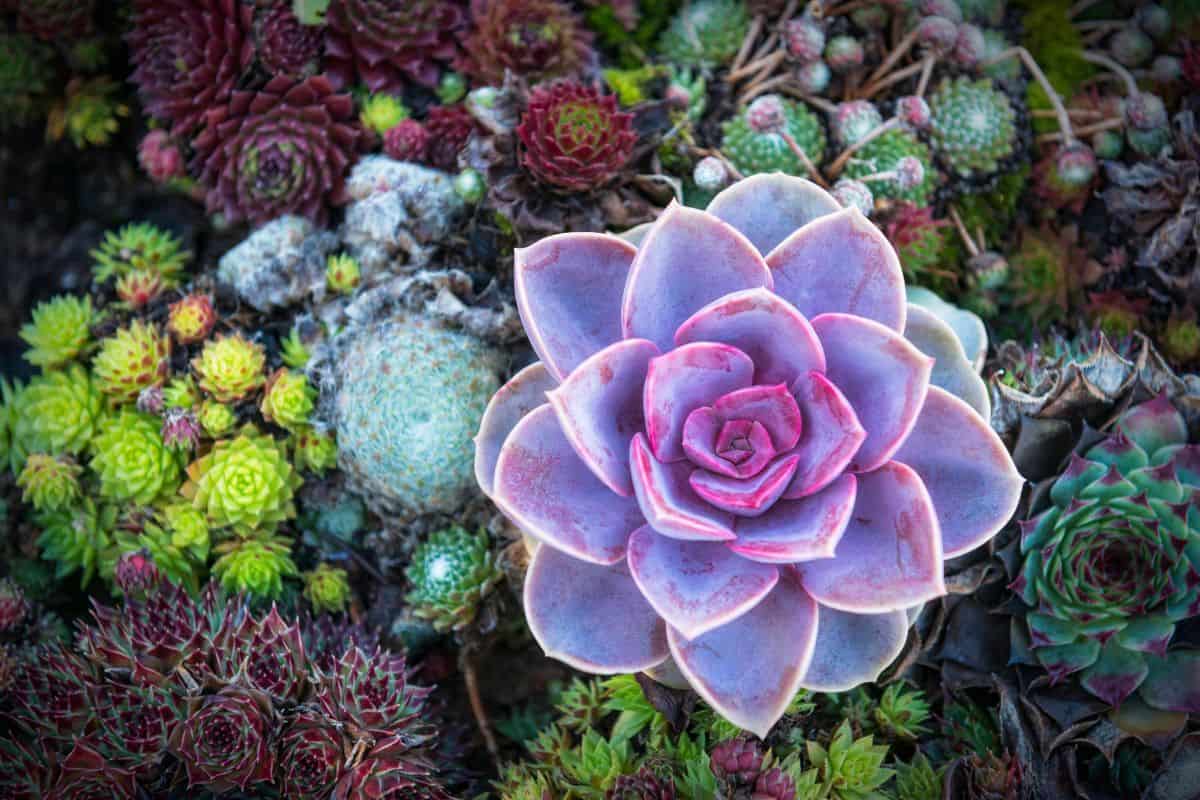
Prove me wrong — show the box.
[492,404,642,564]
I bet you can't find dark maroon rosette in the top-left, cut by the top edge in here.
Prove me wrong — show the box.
[127,0,254,136]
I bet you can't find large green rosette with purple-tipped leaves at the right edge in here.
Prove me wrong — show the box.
[1014,395,1200,712]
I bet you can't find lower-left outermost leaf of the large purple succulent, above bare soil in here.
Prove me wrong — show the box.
[524,545,668,674]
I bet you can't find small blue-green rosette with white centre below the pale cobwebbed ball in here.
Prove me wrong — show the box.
[404,525,502,631]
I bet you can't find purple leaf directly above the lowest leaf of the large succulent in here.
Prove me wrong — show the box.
[629,525,779,639]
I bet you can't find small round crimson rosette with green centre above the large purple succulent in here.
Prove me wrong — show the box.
[517,80,637,192]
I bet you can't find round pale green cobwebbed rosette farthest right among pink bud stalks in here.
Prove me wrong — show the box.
[929,77,1016,178]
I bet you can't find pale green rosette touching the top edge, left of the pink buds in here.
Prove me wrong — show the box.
[659,0,750,70]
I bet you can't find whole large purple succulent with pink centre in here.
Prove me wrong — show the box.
[476,175,1021,734]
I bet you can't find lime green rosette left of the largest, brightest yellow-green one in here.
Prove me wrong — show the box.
[89,409,181,505]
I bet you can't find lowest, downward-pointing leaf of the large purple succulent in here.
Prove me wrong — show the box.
[667,576,817,736]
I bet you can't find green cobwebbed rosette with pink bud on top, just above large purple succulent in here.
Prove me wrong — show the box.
[721,95,826,175]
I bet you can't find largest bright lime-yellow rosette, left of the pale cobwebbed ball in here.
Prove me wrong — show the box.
[180,429,304,534]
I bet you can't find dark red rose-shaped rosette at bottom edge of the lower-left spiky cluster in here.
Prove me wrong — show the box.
[170,685,276,793]
